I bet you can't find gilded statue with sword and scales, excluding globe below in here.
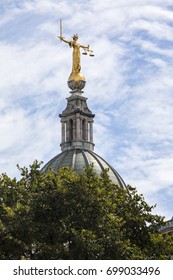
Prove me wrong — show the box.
[58,20,94,82]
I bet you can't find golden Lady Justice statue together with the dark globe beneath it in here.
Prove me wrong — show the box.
[58,19,94,90]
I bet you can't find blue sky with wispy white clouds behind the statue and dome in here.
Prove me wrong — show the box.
[0,0,173,219]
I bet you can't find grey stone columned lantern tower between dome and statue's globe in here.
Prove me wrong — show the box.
[59,90,95,151]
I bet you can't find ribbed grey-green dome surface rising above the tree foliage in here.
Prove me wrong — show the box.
[42,148,125,188]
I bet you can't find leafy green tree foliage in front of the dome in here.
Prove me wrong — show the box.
[0,162,172,260]
